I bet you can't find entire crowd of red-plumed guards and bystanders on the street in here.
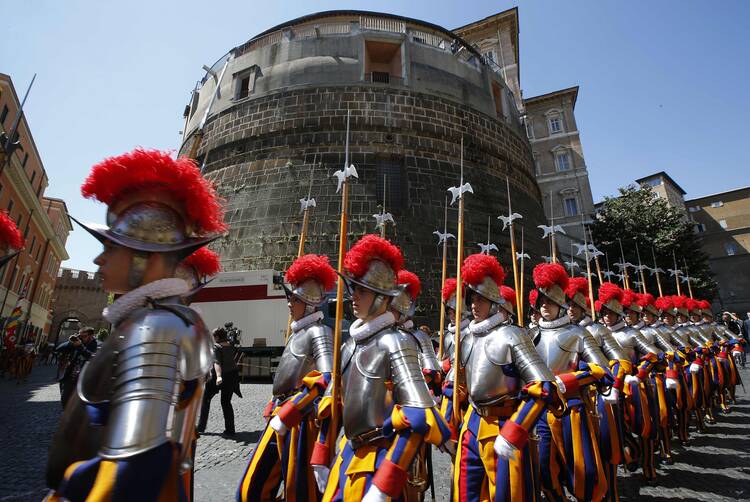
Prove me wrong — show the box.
[0,149,745,502]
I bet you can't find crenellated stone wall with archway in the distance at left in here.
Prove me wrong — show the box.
[49,268,110,345]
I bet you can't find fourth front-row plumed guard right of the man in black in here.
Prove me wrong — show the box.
[533,263,614,501]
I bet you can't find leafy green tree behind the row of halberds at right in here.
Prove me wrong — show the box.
[591,185,717,300]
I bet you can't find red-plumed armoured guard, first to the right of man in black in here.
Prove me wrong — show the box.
[237,254,336,502]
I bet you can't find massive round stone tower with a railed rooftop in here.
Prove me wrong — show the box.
[181,11,545,324]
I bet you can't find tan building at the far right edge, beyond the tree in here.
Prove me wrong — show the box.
[685,187,750,313]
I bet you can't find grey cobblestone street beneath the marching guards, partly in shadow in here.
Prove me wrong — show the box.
[0,366,750,502]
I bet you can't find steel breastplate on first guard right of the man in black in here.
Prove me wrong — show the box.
[273,322,333,396]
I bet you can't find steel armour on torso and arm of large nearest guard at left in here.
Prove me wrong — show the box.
[78,300,213,459]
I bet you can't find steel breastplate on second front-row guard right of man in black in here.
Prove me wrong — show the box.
[342,327,435,438]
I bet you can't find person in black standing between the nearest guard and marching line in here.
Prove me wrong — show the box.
[196,328,242,436]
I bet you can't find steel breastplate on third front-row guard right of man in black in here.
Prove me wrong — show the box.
[461,325,553,406]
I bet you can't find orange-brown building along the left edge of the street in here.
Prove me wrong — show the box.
[0,73,72,342]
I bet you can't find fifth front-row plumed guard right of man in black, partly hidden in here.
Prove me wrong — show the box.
[565,277,633,501]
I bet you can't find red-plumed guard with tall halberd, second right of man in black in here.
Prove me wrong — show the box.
[313,235,450,502]
